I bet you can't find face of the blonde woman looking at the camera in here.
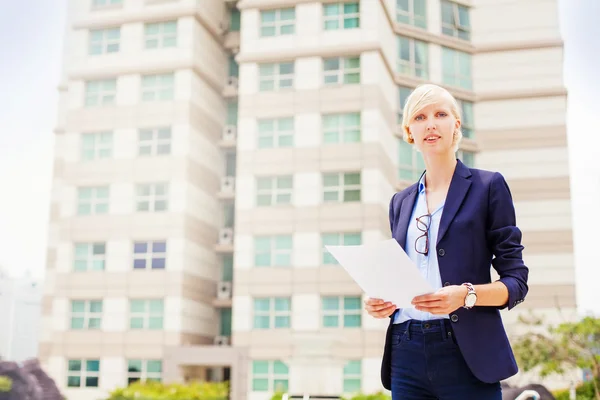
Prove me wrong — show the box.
[408,99,460,155]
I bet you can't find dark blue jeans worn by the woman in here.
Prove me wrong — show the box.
[392,319,502,400]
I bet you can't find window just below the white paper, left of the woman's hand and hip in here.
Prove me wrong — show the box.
[321,296,362,328]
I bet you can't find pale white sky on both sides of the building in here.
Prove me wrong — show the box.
[0,0,600,315]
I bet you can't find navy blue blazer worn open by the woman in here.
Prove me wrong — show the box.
[381,160,529,390]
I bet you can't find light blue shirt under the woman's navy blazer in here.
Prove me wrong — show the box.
[394,175,449,324]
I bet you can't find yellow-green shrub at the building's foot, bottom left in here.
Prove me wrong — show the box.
[107,382,229,400]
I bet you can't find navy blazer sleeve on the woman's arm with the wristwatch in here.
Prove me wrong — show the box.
[486,172,529,310]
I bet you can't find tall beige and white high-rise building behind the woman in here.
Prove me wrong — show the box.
[40,0,575,400]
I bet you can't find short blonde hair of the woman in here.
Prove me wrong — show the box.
[402,83,462,152]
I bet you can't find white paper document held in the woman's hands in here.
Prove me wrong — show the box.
[325,239,434,308]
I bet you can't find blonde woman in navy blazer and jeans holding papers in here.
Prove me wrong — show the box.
[365,84,529,400]
